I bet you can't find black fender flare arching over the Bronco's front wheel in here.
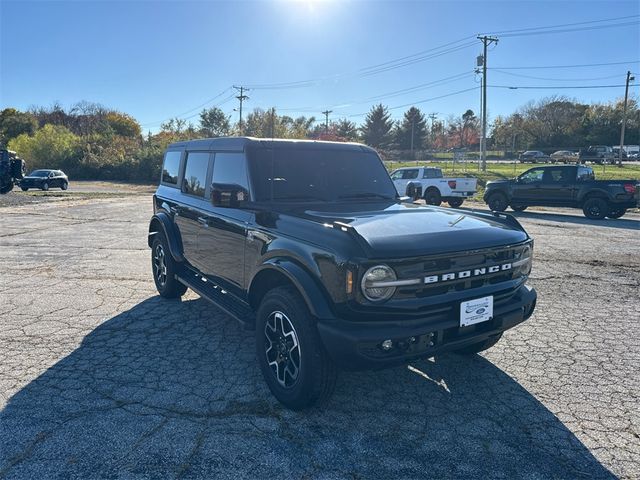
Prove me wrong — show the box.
[249,257,335,320]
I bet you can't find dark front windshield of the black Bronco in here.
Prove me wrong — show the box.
[249,146,397,202]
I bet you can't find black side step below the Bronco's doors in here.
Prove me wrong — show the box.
[176,267,256,330]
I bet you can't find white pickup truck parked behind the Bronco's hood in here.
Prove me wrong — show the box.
[391,167,478,208]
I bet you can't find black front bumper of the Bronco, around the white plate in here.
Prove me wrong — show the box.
[318,285,537,370]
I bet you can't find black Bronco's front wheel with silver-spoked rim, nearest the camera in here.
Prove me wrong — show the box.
[256,286,337,410]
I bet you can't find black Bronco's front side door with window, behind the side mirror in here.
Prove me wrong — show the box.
[198,152,252,297]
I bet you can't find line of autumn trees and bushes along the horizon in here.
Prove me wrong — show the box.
[0,97,640,181]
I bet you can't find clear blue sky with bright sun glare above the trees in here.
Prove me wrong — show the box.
[0,0,640,131]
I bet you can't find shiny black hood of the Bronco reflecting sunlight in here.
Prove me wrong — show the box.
[287,203,529,258]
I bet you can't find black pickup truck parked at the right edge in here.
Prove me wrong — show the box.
[484,165,640,219]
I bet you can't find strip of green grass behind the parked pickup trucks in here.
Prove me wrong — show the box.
[385,161,640,200]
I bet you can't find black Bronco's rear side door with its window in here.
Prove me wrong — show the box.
[174,152,211,269]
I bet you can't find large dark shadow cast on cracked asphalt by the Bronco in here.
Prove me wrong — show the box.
[0,297,614,479]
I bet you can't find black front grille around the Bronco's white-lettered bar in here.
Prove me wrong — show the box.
[390,244,528,300]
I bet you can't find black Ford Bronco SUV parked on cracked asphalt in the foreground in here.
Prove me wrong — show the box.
[148,138,536,409]
